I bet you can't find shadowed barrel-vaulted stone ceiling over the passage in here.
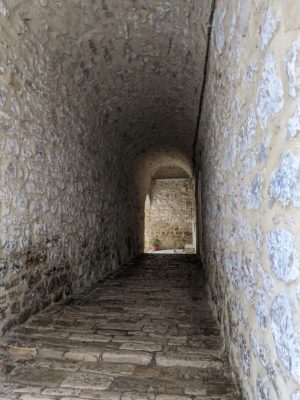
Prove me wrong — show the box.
[3,0,211,161]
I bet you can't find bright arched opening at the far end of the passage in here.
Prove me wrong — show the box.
[144,167,196,254]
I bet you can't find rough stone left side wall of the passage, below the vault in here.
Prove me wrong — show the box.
[0,2,142,331]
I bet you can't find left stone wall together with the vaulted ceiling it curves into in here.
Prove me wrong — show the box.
[0,0,210,331]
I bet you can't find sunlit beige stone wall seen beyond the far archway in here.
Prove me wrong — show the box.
[145,179,194,251]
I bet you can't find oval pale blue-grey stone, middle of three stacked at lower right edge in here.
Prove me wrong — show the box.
[267,228,299,283]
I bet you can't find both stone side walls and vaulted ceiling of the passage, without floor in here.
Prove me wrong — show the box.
[0,0,300,400]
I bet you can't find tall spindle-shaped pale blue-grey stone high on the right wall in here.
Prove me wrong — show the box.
[257,53,284,128]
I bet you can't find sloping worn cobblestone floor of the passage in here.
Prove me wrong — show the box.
[0,255,241,400]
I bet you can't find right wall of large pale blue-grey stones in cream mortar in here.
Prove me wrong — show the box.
[197,0,300,400]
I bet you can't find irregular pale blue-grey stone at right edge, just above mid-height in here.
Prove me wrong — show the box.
[268,153,300,207]
